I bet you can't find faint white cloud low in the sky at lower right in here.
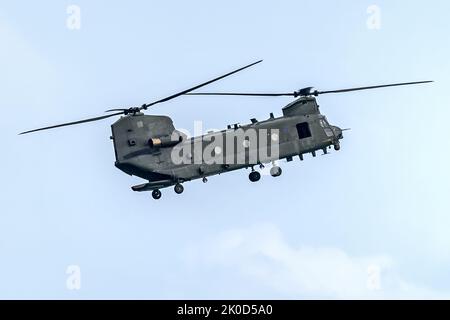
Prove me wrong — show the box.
[185,224,450,299]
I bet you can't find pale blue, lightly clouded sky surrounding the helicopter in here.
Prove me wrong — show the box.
[0,0,450,299]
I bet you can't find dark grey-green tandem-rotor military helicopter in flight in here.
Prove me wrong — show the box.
[20,60,432,199]
